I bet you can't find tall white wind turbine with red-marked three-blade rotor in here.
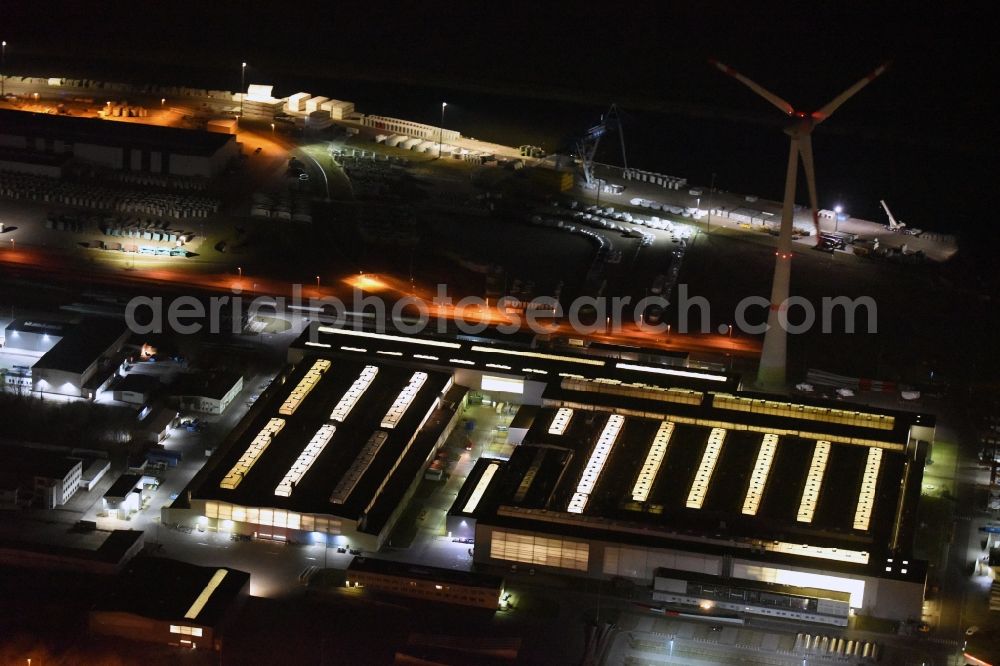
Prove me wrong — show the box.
[709,60,889,388]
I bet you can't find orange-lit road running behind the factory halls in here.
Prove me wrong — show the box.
[0,243,760,357]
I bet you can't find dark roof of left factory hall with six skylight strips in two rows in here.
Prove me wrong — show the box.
[193,359,461,530]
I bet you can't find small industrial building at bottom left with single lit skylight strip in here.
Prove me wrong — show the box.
[89,557,250,650]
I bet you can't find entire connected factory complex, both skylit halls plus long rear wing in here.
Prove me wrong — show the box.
[165,323,934,625]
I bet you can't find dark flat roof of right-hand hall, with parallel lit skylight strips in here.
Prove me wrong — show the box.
[450,398,921,578]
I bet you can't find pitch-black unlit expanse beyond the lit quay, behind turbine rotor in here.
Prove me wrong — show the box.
[0,0,1000,232]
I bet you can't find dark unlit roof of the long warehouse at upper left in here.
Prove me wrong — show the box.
[0,109,235,156]
